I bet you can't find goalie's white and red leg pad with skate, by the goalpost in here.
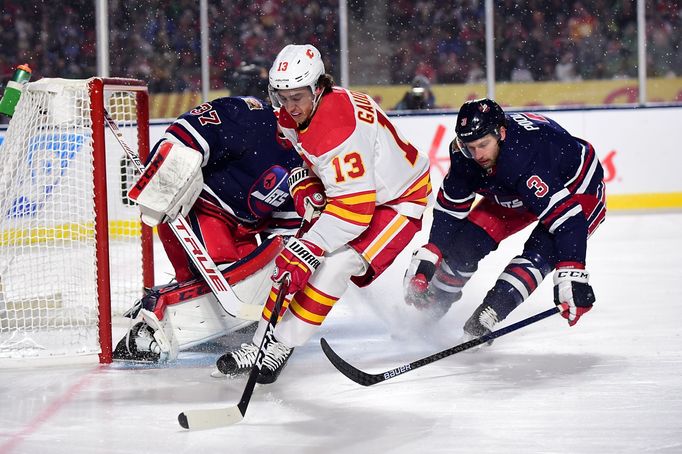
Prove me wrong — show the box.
[114,236,284,362]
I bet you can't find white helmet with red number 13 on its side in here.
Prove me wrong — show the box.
[268,44,324,107]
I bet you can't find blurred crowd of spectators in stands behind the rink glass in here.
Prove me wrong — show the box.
[0,0,682,93]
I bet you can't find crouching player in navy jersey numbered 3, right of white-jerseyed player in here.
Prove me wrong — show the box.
[404,99,606,338]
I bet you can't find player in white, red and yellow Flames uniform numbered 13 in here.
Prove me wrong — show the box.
[217,45,431,383]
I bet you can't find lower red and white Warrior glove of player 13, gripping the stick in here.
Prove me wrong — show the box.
[272,237,324,293]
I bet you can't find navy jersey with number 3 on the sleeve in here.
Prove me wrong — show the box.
[436,113,604,263]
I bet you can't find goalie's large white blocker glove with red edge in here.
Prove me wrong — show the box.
[128,141,204,227]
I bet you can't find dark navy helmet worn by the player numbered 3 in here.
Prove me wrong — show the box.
[455,98,507,158]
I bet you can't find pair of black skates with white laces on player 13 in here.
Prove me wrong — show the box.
[214,336,294,384]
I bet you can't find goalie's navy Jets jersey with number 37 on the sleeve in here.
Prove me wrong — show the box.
[152,97,303,233]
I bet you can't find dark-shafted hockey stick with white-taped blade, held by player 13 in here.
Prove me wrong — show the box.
[178,280,289,430]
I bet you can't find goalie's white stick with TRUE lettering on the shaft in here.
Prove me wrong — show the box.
[104,109,262,321]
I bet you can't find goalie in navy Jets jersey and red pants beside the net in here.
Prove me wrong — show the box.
[114,80,322,361]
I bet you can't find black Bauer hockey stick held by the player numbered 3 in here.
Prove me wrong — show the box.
[320,307,560,386]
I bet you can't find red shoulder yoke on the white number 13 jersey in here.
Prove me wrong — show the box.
[299,89,356,156]
